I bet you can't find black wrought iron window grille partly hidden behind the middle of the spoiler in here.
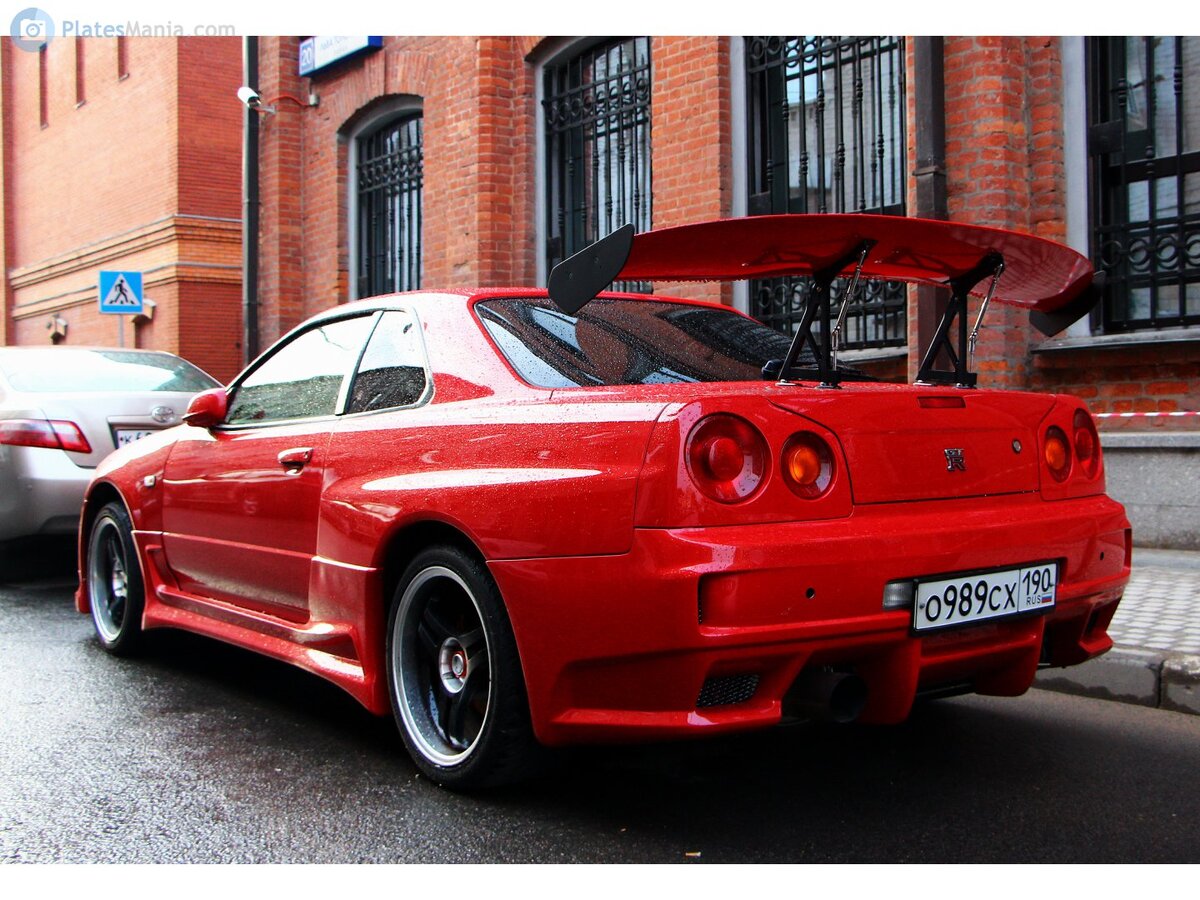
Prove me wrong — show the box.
[745,36,907,349]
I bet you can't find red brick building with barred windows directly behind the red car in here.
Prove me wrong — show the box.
[248,37,1200,413]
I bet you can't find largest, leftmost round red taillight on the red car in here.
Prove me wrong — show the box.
[685,413,768,503]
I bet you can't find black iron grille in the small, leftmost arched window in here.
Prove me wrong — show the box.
[358,114,422,296]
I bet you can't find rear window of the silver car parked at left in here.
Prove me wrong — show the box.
[0,349,217,394]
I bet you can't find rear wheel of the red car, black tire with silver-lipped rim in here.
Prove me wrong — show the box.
[386,546,541,790]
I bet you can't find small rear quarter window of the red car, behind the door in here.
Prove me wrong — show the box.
[346,311,427,413]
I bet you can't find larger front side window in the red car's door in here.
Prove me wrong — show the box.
[226,316,374,425]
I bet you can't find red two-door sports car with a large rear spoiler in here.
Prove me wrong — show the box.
[77,216,1130,787]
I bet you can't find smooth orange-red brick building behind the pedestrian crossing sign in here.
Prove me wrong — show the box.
[0,37,242,378]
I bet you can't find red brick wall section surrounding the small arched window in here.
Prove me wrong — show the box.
[259,37,506,331]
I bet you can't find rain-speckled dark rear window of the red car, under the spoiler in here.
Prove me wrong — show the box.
[475,298,791,388]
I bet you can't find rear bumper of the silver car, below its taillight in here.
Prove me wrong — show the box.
[0,446,95,540]
